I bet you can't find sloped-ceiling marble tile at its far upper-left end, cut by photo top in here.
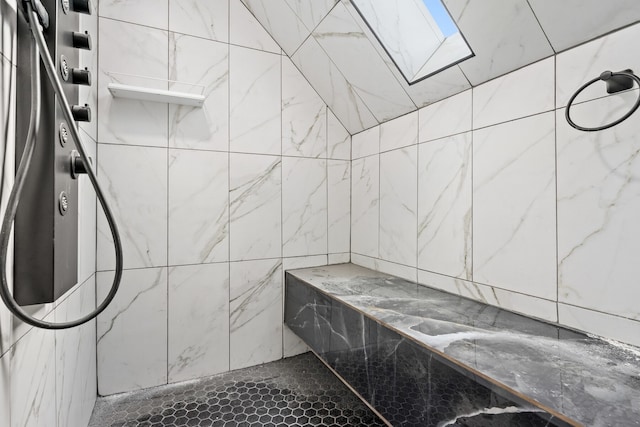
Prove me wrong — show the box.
[240,0,311,56]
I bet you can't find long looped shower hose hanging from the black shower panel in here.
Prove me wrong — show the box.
[0,2,123,329]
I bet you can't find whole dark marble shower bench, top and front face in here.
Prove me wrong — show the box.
[285,264,640,426]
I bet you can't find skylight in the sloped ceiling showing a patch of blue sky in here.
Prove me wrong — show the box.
[351,0,473,84]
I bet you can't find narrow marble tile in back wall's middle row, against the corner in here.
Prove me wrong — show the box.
[327,160,351,253]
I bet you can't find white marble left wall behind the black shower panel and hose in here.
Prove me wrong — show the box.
[0,0,97,427]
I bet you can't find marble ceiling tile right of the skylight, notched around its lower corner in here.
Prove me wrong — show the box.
[444,0,553,86]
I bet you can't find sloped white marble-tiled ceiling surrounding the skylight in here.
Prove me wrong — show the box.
[242,0,640,134]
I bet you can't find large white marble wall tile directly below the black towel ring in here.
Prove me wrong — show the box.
[556,91,640,320]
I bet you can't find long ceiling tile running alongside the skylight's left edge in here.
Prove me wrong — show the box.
[313,3,416,121]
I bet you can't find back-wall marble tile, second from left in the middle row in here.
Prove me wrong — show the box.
[168,150,229,265]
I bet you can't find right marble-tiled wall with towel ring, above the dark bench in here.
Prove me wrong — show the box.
[352,20,640,345]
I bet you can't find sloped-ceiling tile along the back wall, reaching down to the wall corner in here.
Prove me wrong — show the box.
[291,37,378,134]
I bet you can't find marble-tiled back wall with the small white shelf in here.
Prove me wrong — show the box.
[92,0,351,394]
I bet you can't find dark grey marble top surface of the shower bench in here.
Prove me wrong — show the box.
[288,264,640,426]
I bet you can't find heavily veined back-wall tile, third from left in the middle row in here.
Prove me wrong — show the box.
[229,154,282,261]
